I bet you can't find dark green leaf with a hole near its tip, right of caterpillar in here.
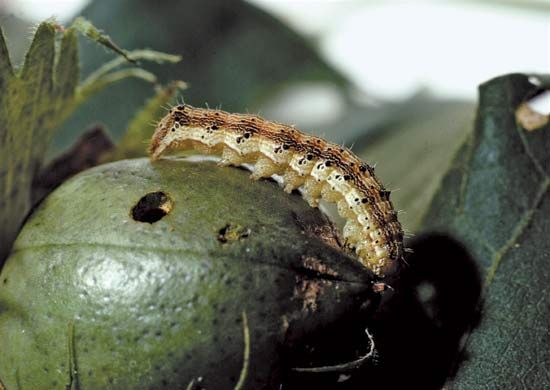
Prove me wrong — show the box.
[423,74,550,389]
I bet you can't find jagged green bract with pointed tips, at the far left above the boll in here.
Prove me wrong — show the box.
[0,19,181,264]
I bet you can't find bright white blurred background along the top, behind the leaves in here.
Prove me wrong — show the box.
[4,0,550,106]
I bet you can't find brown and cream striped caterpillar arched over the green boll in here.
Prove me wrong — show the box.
[149,104,404,277]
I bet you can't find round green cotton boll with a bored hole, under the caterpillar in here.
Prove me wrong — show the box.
[0,159,380,390]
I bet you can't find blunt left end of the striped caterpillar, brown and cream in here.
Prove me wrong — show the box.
[149,104,191,160]
